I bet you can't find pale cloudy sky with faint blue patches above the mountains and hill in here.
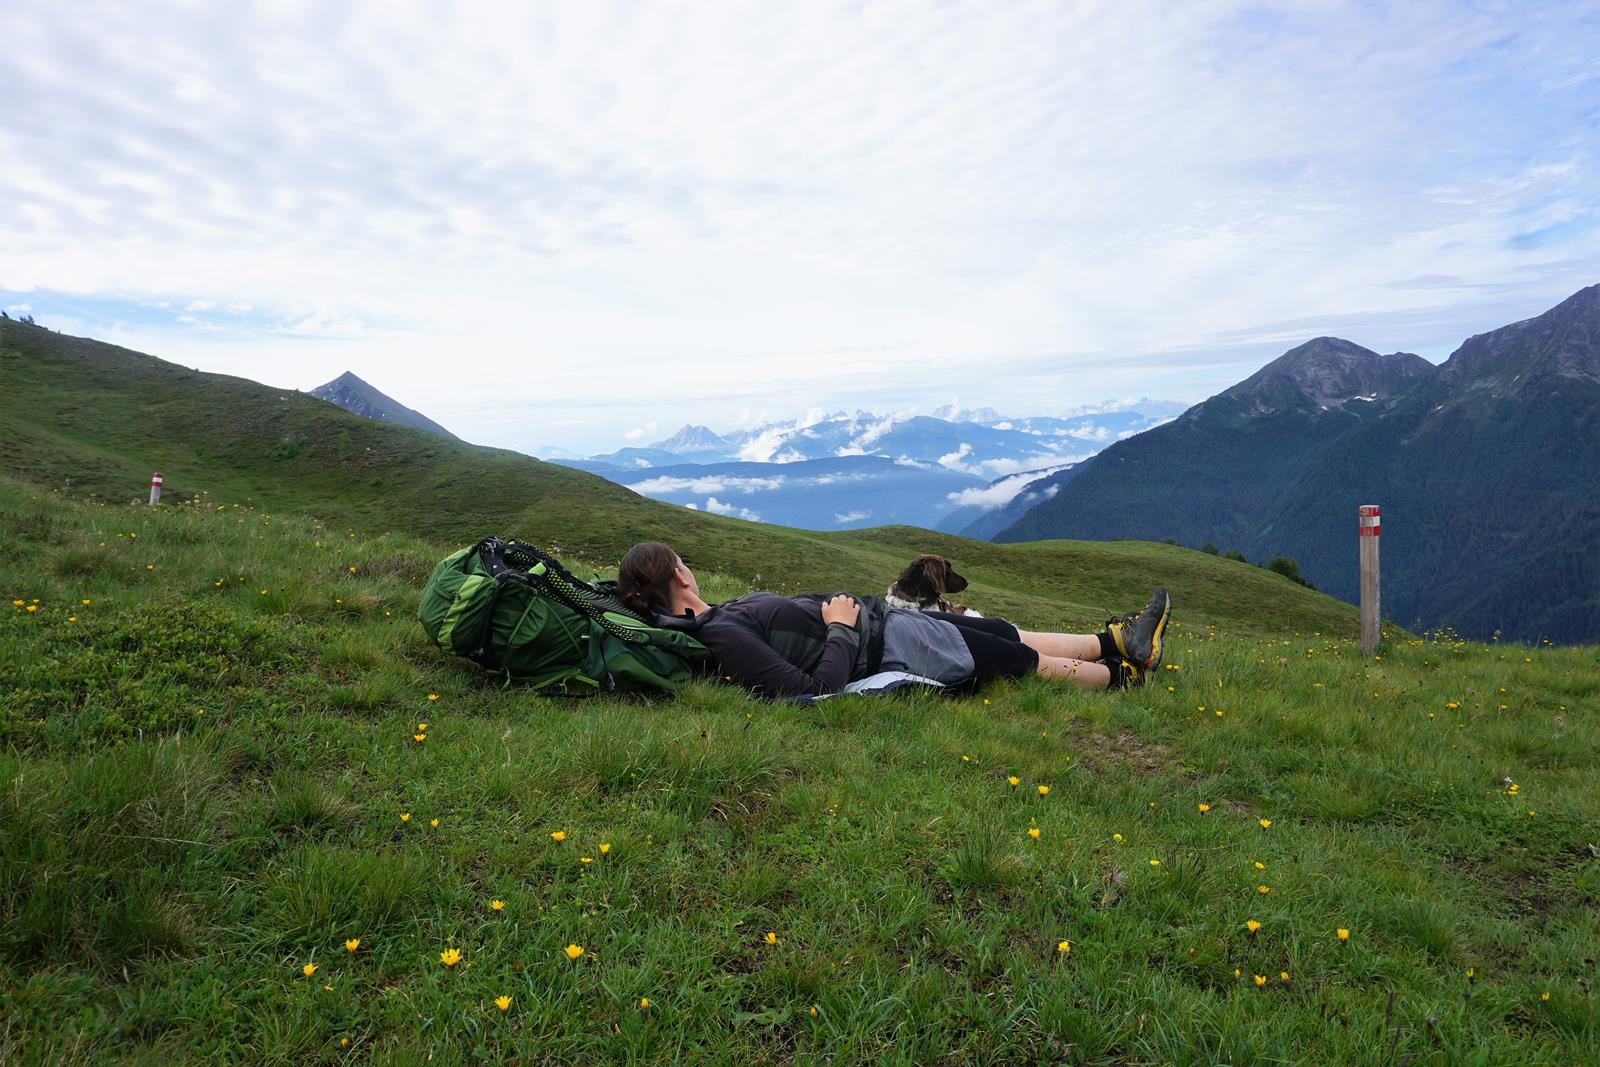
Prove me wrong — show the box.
[0,0,1600,451]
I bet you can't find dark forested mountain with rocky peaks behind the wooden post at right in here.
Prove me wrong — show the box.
[995,285,1600,643]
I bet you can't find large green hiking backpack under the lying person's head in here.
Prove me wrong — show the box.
[416,537,710,693]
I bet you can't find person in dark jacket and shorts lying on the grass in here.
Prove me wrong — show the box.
[618,541,1171,697]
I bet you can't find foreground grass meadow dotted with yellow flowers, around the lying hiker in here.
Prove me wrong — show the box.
[0,479,1600,1064]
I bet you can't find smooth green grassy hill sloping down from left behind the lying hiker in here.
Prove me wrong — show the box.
[0,320,1357,633]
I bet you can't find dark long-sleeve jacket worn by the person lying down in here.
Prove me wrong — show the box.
[693,593,888,697]
